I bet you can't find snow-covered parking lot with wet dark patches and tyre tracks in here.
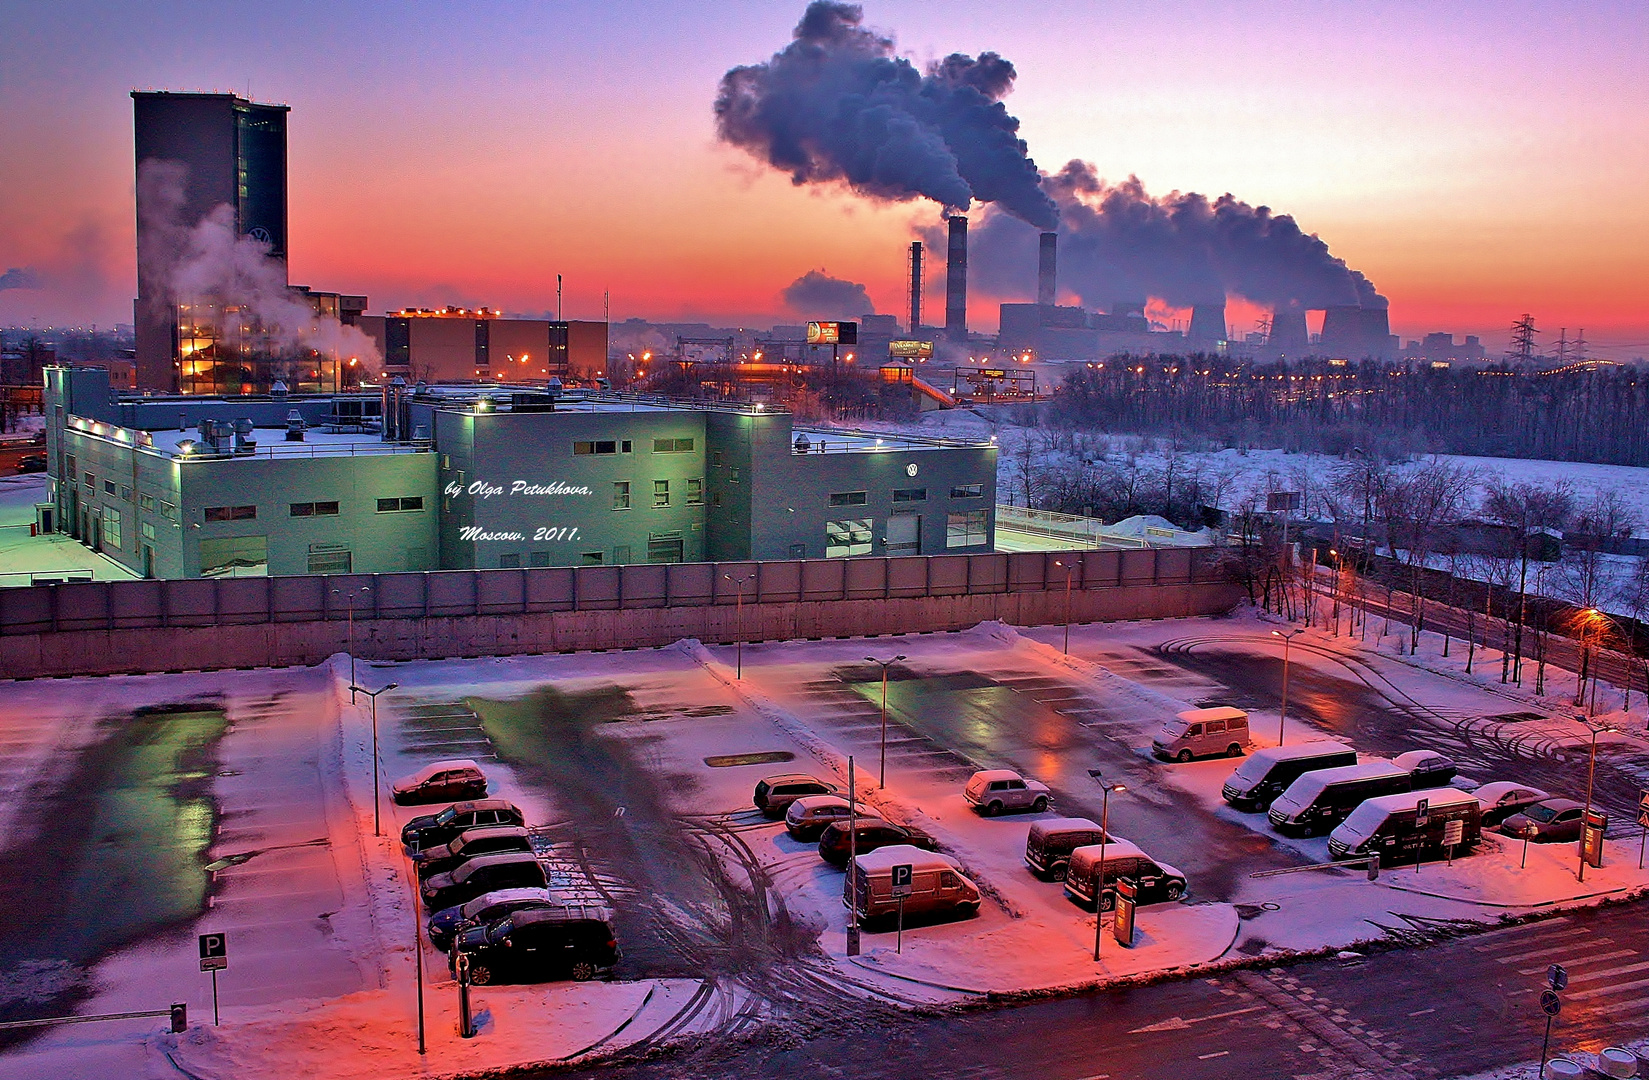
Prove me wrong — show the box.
[0,615,1649,1078]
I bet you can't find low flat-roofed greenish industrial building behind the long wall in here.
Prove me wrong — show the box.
[38,366,996,577]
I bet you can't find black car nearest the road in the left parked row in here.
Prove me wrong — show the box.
[447,904,618,986]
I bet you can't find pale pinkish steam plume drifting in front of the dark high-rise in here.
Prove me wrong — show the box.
[137,160,381,369]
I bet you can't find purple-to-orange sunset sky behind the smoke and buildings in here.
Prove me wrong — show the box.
[0,0,1649,359]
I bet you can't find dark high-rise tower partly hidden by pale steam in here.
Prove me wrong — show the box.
[132,91,289,391]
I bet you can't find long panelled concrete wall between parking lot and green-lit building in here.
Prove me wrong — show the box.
[0,549,1242,678]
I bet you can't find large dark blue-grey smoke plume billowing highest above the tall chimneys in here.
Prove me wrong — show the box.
[716,0,1057,228]
